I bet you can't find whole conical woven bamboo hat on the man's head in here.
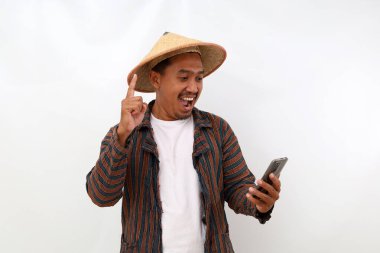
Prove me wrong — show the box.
[128,32,227,92]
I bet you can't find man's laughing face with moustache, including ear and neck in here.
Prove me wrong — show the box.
[151,53,204,120]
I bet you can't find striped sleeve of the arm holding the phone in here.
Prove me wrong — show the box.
[222,120,273,224]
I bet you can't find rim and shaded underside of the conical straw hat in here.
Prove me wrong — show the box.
[128,42,227,92]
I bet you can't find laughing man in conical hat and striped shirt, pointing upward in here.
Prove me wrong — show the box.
[86,33,280,253]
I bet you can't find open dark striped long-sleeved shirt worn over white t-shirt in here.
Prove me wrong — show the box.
[86,100,273,253]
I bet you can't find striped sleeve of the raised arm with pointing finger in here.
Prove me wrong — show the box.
[86,125,130,207]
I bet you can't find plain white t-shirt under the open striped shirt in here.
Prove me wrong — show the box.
[151,114,205,253]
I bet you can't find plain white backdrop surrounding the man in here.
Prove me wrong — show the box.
[0,0,380,253]
